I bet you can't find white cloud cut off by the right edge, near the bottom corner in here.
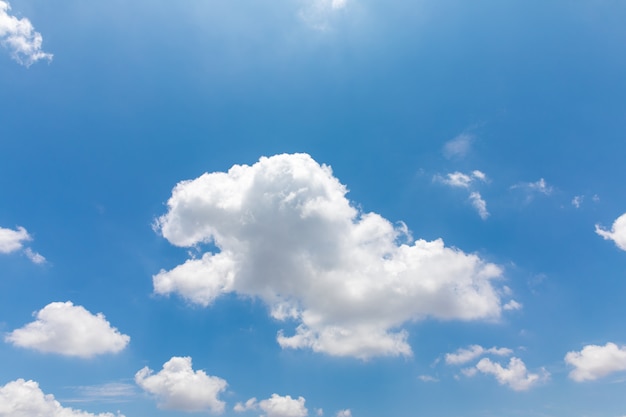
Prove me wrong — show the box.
[565,343,626,382]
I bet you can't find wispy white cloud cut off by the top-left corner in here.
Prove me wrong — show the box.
[0,0,52,67]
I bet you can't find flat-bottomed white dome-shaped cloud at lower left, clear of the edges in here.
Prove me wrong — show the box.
[5,301,130,358]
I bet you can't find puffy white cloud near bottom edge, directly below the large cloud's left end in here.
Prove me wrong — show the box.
[135,357,228,413]
